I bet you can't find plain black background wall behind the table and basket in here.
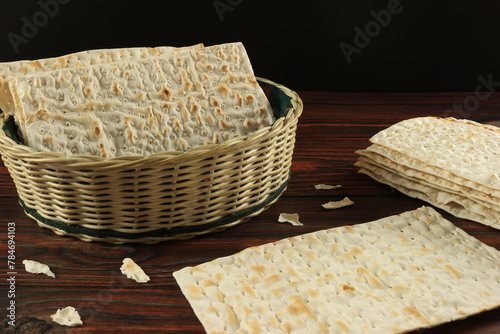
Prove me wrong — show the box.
[0,0,500,92]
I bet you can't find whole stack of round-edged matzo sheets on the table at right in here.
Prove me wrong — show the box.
[355,117,500,228]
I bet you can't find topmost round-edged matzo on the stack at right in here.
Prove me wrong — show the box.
[370,117,500,191]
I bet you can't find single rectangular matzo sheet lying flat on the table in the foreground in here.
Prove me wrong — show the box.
[174,207,500,333]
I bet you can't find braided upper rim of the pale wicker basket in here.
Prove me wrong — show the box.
[0,77,302,164]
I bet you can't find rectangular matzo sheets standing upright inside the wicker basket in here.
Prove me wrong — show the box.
[0,43,275,157]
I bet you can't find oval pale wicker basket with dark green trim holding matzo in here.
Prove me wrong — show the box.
[0,78,302,243]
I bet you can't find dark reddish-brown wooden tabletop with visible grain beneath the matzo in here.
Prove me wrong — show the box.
[0,92,500,334]
